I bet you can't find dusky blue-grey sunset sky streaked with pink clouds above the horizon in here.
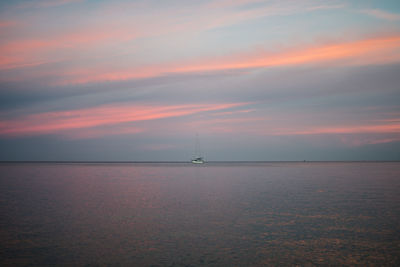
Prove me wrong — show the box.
[0,0,400,161]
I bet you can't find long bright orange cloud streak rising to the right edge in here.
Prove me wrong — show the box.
[59,35,400,84]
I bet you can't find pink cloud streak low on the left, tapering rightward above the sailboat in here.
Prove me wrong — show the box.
[0,103,244,136]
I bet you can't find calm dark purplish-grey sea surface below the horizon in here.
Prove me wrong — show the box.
[0,162,400,266]
